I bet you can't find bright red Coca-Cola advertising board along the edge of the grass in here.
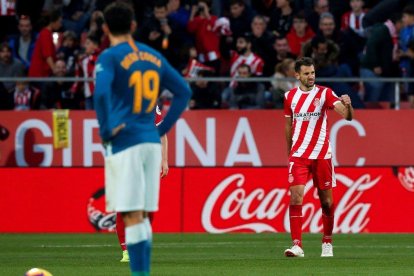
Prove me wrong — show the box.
[0,167,414,233]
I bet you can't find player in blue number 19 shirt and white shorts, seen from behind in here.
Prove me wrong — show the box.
[94,2,191,276]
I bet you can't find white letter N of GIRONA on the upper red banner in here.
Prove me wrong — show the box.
[175,118,216,167]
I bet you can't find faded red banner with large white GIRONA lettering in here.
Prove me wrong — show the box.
[0,110,414,167]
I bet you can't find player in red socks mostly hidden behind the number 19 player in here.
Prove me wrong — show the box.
[116,105,168,263]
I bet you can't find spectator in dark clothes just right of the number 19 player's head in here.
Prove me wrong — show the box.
[135,0,180,67]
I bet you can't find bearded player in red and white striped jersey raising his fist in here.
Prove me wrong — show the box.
[284,57,354,257]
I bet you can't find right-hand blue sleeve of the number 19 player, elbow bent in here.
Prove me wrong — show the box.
[158,55,192,136]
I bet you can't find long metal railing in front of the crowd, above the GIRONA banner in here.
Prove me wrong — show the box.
[0,77,414,110]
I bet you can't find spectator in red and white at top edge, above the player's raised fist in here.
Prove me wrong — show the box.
[341,0,365,37]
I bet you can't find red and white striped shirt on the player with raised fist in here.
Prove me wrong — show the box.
[284,85,341,159]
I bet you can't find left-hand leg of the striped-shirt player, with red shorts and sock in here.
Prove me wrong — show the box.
[285,157,310,257]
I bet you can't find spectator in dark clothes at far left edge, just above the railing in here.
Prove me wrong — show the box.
[0,42,24,91]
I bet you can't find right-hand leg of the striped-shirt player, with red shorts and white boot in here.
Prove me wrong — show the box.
[312,159,336,257]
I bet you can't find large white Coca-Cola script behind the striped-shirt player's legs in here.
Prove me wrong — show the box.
[201,173,381,233]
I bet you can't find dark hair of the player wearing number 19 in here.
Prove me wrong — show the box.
[104,2,134,35]
